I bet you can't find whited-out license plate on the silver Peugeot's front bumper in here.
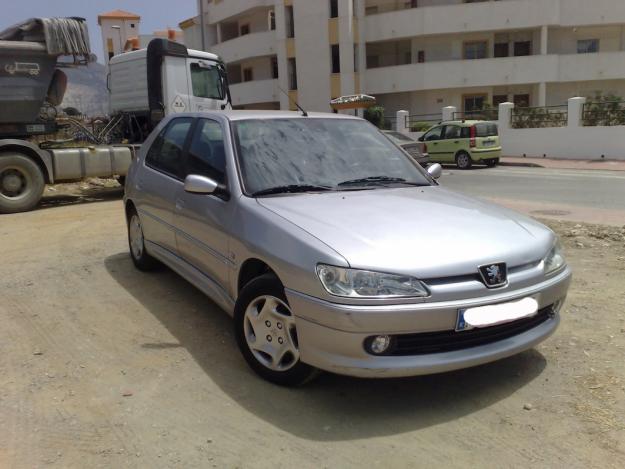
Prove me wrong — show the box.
[456,297,538,332]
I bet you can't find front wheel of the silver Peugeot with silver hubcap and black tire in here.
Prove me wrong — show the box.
[234,273,317,386]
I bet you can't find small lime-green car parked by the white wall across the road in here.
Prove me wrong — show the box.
[419,120,501,169]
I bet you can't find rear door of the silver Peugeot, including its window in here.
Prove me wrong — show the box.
[135,117,193,252]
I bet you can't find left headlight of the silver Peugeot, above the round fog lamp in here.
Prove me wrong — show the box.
[317,264,429,298]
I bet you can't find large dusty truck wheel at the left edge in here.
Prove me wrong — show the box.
[0,153,46,213]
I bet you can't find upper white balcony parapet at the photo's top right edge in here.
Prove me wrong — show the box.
[364,0,625,42]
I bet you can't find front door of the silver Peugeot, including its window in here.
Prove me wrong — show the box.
[174,118,234,289]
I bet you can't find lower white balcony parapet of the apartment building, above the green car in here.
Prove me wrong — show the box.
[365,52,625,94]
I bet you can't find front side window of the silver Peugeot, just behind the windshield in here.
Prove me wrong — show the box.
[186,119,226,184]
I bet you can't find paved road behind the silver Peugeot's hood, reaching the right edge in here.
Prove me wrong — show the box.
[440,167,625,226]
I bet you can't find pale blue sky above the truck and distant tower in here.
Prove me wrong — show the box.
[0,0,197,63]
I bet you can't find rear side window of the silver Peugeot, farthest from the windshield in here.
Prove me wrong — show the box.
[145,117,193,178]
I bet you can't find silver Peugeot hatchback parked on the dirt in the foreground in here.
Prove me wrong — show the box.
[125,111,571,385]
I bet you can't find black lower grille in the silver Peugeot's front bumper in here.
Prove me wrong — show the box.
[387,305,553,356]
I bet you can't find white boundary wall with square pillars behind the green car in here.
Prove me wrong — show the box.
[397,97,625,161]
